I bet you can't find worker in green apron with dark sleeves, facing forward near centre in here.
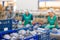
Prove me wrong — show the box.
[22,10,33,25]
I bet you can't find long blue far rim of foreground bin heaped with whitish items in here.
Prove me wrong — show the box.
[0,27,33,39]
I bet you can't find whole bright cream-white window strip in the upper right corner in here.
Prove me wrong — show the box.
[39,1,60,7]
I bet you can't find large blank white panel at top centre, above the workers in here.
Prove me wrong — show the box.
[16,0,38,10]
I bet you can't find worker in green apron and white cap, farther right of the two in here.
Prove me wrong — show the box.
[45,8,58,29]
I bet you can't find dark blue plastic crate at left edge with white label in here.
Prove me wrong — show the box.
[0,19,12,31]
